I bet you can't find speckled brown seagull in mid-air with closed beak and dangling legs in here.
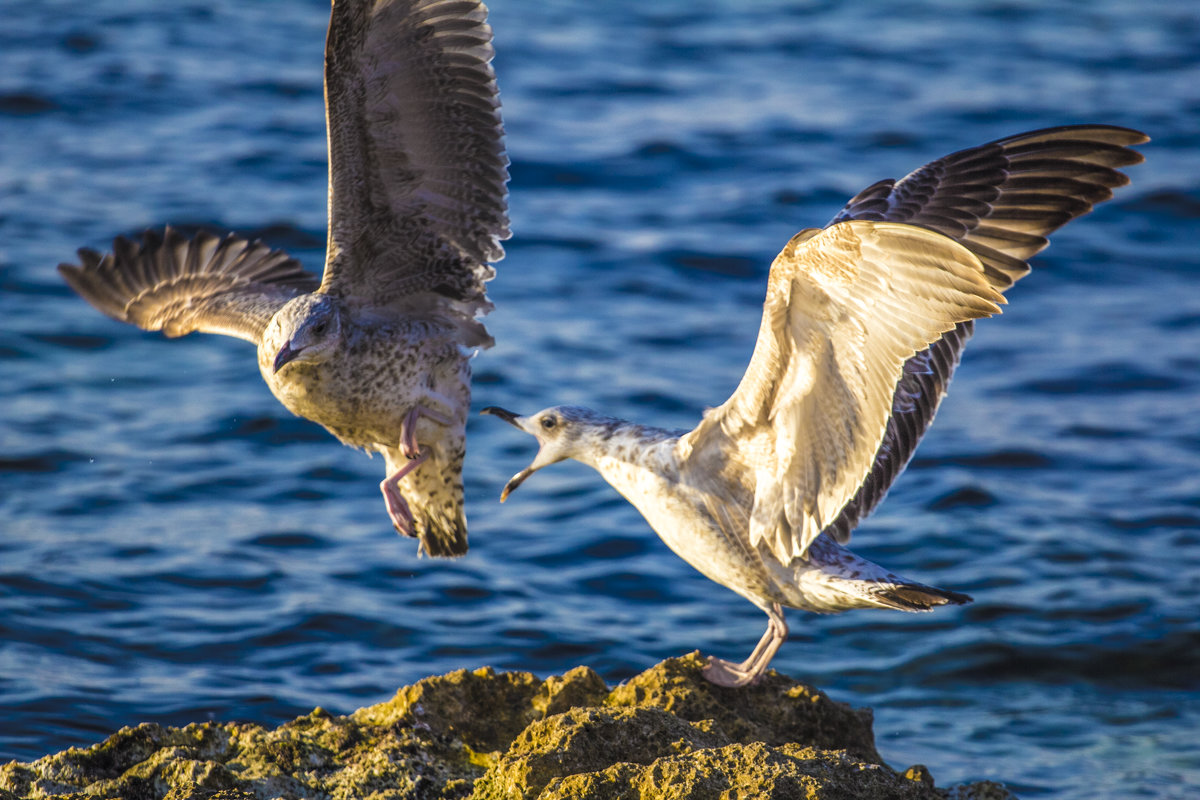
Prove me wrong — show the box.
[59,0,510,557]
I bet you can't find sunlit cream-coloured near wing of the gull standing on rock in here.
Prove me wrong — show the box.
[684,221,1003,564]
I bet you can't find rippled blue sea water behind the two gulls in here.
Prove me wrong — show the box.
[0,0,1200,800]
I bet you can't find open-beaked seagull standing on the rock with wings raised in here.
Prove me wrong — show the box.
[484,125,1148,686]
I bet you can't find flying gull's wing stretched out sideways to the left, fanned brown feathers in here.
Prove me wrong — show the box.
[59,228,317,344]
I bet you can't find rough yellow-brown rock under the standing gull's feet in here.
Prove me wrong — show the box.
[0,654,1012,800]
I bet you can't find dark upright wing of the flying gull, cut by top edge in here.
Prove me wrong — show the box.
[322,0,509,314]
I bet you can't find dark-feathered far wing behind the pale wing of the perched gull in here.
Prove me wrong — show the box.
[827,125,1148,543]
